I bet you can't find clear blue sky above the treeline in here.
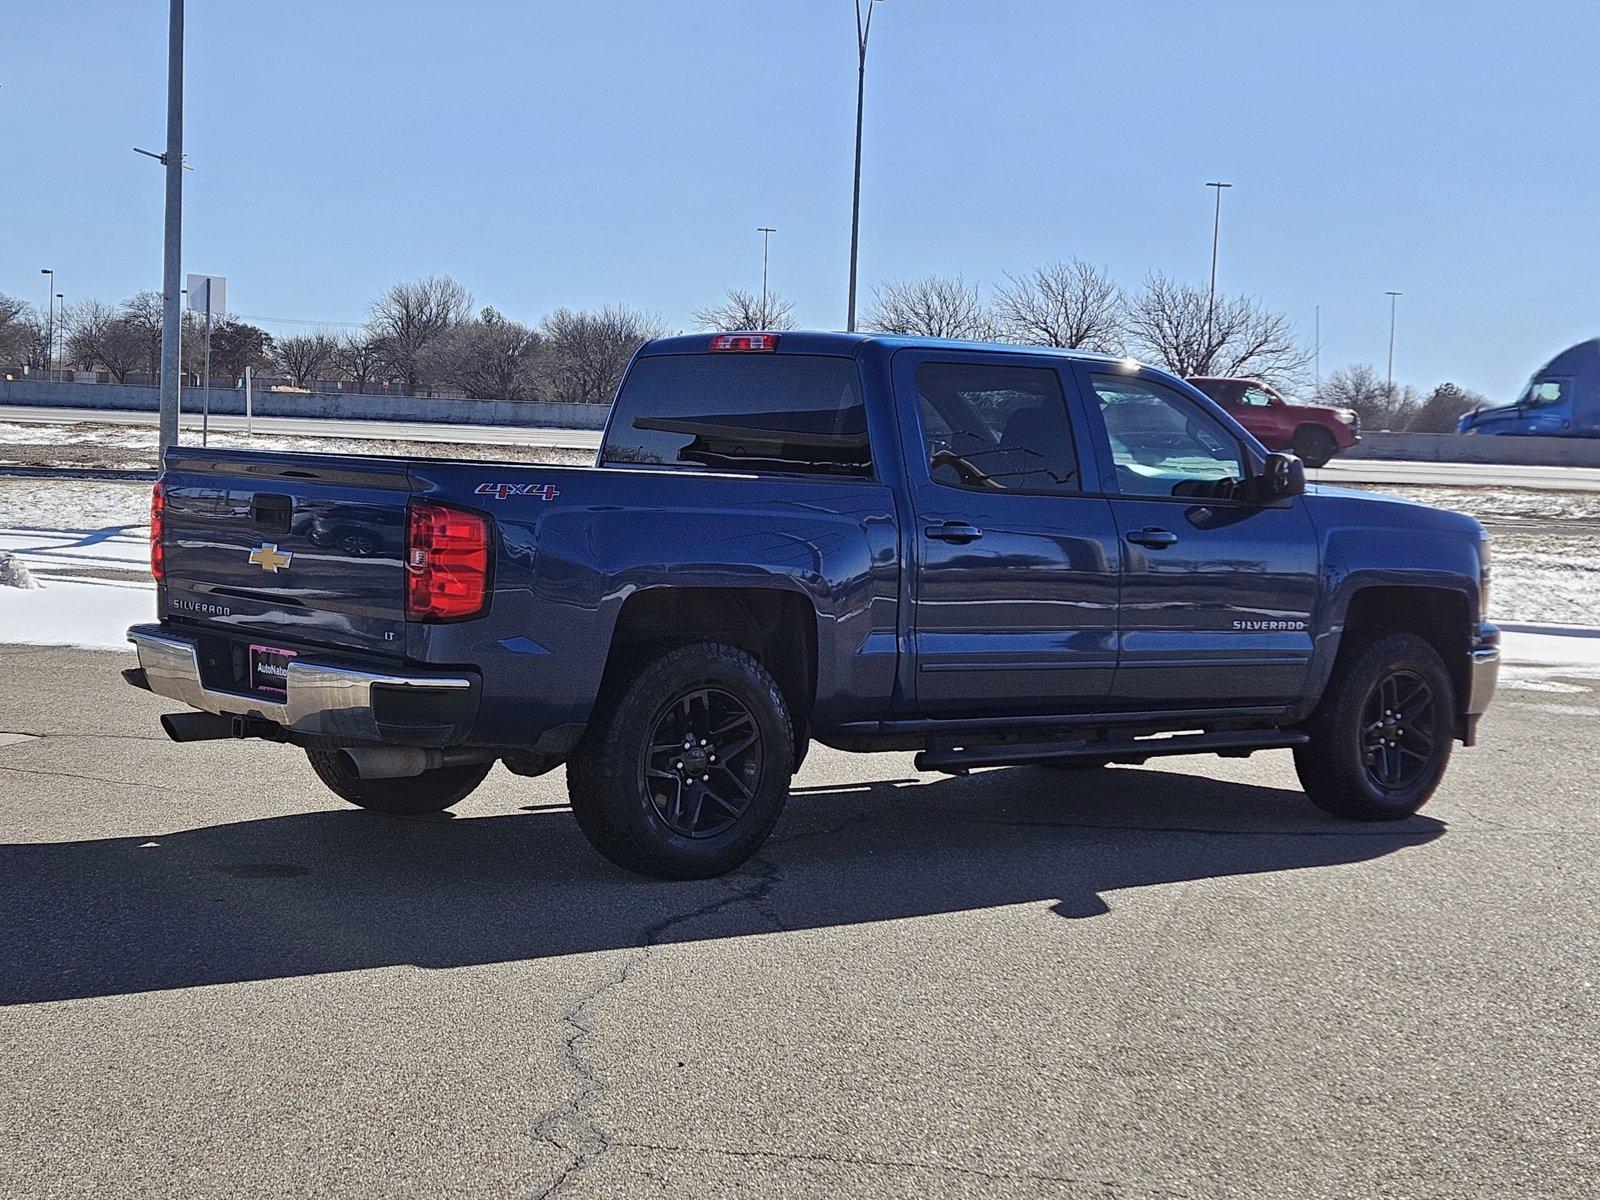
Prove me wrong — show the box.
[0,0,1600,397]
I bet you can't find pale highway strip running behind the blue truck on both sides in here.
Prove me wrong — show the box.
[9,405,1600,491]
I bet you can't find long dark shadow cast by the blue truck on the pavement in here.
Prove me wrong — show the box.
[0,768,1445,1005]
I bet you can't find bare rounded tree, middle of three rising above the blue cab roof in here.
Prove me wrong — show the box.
[994,258,1126,354]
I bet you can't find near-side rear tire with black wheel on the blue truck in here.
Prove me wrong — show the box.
[566,642,795,880]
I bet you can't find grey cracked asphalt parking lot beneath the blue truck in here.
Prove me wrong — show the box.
[0,646,1600,1200]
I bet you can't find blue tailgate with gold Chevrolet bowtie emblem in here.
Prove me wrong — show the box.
[162,448,411,656]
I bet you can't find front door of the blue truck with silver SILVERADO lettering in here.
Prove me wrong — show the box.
[1075,363,1318,707]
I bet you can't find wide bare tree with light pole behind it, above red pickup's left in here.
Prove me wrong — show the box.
[1128,272,1312,384]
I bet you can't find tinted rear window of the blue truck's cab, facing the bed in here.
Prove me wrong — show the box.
[600,354,872,478]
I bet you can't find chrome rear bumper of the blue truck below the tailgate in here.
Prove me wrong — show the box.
[128,626,475,744]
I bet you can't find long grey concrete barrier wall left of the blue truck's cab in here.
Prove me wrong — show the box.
[0,379,611,429]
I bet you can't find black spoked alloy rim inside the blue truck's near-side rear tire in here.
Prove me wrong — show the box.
[640,686,763,838]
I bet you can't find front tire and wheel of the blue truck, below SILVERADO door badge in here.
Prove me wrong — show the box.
[1294,634,1456,821]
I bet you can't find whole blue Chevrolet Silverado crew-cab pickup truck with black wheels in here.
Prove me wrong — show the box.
[125,333,1499,878]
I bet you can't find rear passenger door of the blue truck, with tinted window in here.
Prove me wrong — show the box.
[893,349,1120,717]
